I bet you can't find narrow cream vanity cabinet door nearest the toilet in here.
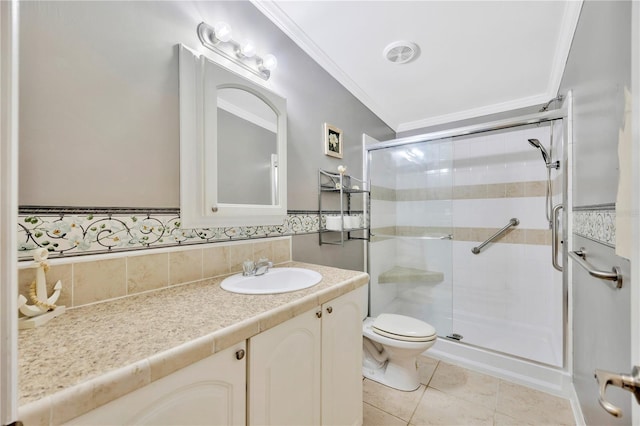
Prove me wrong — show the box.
[322,286,366,425]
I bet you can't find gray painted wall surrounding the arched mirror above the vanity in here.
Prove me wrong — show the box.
[19,1,394,269]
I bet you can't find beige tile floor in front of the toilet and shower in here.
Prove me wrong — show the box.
[363,356,575,426]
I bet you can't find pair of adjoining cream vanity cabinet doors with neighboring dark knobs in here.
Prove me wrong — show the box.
[248,286,366,425]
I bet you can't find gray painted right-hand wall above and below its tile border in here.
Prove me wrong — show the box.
[560,1,631,425]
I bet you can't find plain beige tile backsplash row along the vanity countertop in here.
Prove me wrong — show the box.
[18,237,291,308]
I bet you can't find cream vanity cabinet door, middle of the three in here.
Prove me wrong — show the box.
[248,307,322,425]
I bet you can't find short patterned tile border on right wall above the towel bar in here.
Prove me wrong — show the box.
[573,204,616,247]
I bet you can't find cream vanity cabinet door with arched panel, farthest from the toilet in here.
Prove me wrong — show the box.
[68,342,246,426]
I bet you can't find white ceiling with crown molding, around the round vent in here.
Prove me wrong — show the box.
[254,0,582,132]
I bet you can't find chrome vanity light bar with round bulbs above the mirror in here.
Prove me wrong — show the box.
[198,22,278,80]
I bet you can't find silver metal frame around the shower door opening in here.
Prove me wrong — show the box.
[362,106,572,372]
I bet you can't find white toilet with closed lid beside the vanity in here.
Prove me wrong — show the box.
[362,314,437,391]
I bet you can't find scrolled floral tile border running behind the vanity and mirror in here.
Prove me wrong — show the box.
[18,206,324,260]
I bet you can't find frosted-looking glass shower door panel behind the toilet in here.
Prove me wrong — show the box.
[369,139,453,336]
